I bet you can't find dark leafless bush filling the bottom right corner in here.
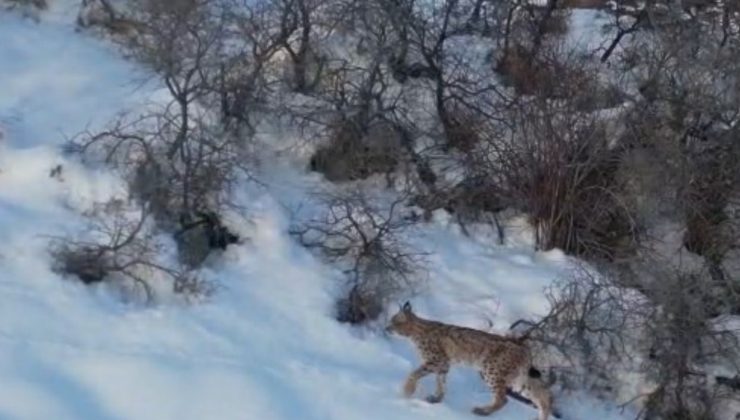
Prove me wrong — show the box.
[644,271,740,419]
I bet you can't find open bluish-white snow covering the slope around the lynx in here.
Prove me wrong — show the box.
[0,1,631,420]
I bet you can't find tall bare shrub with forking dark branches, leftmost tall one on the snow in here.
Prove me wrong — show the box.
[68,0,247,267]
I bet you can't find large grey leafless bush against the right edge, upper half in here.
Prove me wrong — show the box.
[625,9,740,282]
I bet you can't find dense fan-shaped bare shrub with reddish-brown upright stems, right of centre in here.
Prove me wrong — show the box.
[482,94,639,260]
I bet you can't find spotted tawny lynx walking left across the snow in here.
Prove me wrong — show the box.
[387,302,552,420]
